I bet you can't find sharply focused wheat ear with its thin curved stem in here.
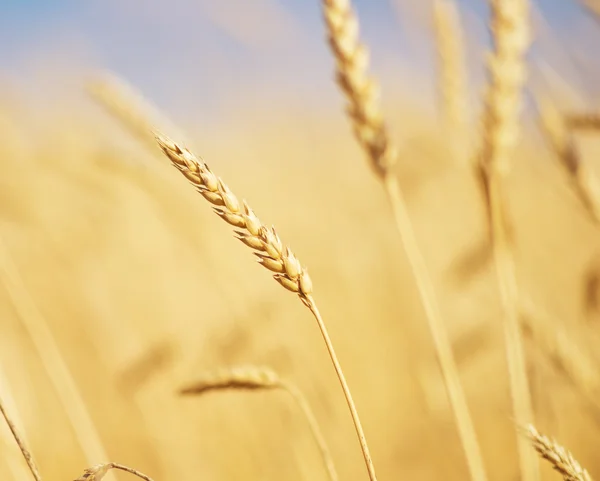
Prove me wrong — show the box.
[156,133,376,481]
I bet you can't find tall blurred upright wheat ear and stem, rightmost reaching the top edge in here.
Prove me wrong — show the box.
[479,0,539,481]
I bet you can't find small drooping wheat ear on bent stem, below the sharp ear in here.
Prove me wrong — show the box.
[180,366,339,481]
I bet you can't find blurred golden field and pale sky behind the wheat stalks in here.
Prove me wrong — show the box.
[0,0,600,481]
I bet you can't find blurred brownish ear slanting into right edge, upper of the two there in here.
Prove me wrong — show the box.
[537,97,600,223]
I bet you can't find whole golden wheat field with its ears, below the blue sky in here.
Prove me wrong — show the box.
[0,0,600,481]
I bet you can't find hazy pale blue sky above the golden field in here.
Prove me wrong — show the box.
[0,0,598,120]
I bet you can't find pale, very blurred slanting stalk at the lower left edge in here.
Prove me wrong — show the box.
[0,237,114,481]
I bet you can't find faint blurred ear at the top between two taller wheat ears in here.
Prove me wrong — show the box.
[433,0,468,162]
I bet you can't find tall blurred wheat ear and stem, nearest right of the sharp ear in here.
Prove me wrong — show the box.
[322,0,487,481]
